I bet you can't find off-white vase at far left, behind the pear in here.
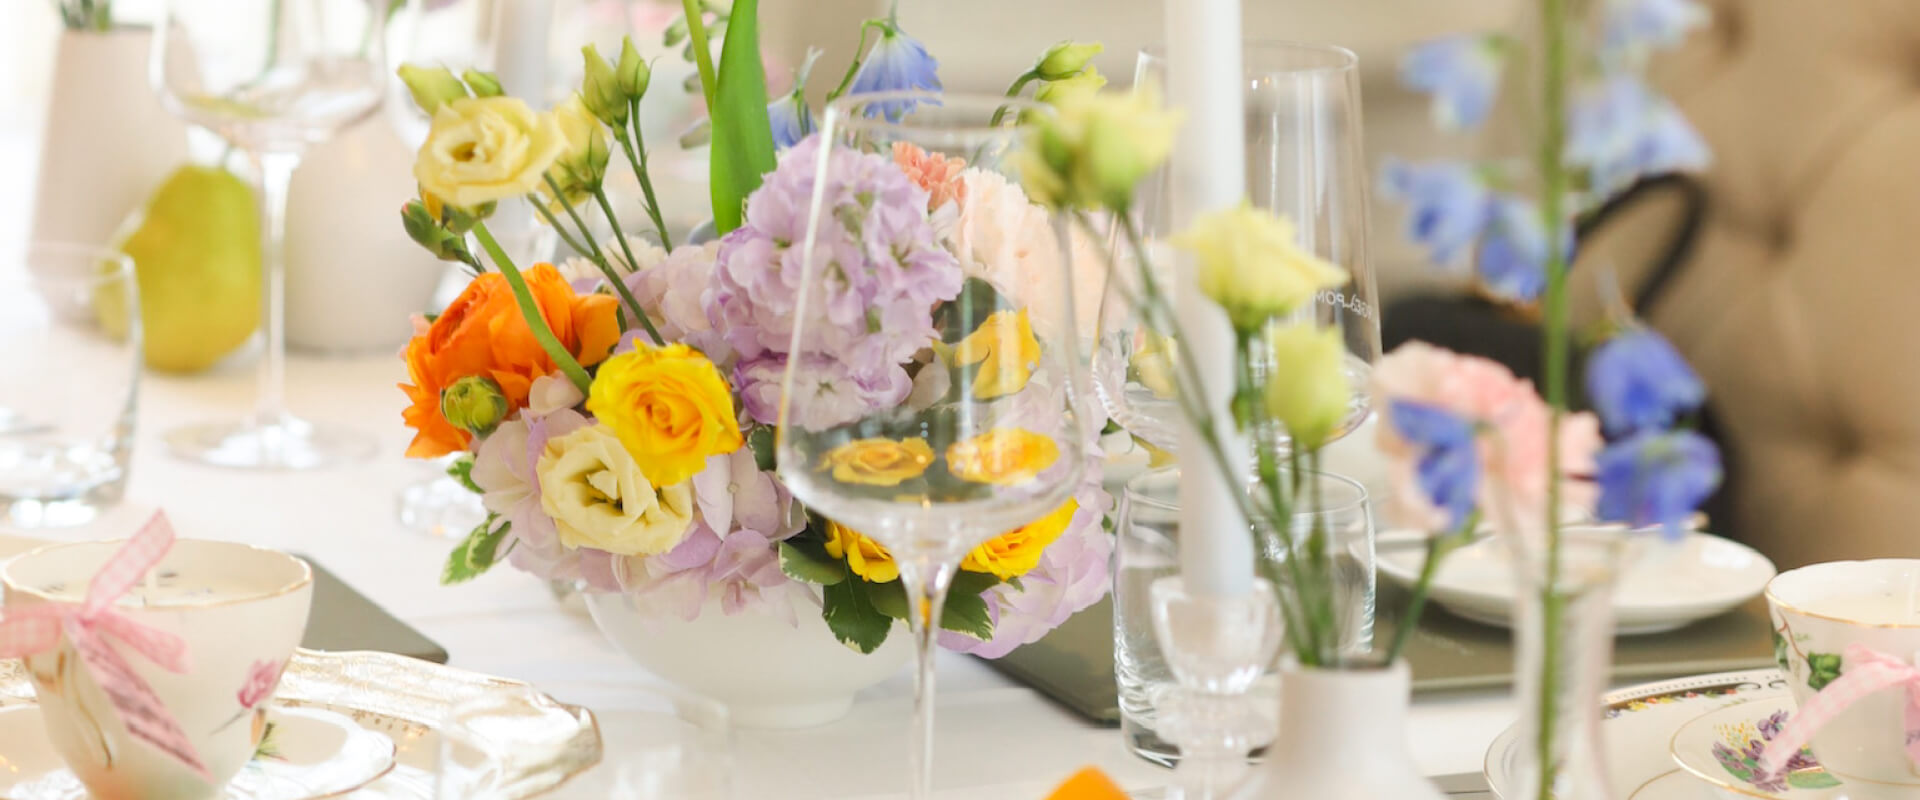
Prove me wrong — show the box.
[27,27,188,246]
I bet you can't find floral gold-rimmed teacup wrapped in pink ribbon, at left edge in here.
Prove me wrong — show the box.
[0,539,313,800]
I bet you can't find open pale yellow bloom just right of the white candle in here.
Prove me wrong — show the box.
[1173,203,1348,332]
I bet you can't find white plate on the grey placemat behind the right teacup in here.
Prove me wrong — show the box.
[1379,531,1774,635]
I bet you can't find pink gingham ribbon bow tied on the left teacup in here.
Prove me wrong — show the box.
[0,512,211,781]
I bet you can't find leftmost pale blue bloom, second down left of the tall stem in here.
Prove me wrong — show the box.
[1380,157,1492,265]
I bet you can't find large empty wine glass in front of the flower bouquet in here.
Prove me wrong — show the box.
[778,92,1092,798]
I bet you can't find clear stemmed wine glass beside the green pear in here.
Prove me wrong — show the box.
[150,0,392,470]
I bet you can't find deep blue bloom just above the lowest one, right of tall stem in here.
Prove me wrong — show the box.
[1586,328,1707,435]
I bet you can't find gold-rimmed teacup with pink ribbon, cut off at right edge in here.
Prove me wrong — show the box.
[1766,558,1920,798]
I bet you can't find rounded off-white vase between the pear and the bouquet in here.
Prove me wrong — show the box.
[286,115,447,355]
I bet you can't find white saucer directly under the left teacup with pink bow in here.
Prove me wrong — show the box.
[0,706,394,800]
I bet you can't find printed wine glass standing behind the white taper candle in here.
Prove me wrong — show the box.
[1092,42,1380,453]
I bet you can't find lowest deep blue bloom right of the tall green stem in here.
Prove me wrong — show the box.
[1594,430,1720,537]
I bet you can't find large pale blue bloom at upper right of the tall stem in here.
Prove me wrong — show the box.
[1567,73,1713,194]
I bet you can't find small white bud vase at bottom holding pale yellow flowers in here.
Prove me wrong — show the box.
[1229,662,1444,800]
